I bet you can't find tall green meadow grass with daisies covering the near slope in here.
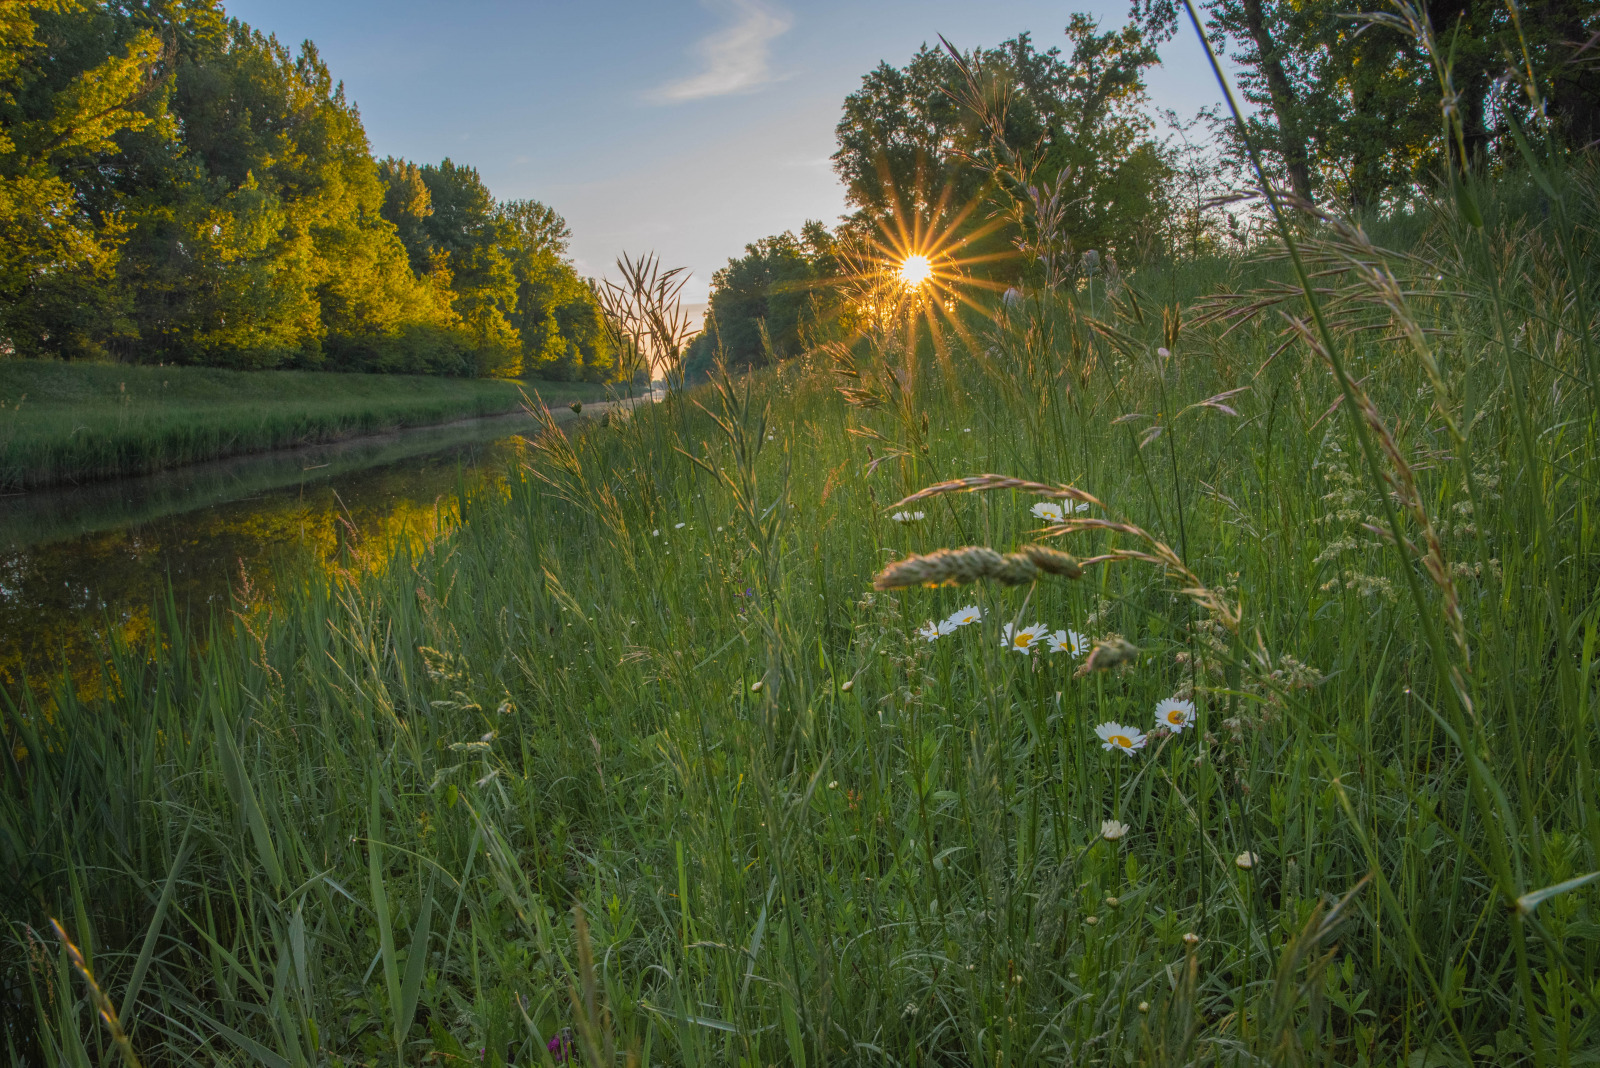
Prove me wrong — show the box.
[0,168,1600,1066]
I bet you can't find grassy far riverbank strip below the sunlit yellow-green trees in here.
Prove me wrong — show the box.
[0,360,605,492]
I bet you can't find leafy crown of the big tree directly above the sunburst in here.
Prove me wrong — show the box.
[834,14,1166,265]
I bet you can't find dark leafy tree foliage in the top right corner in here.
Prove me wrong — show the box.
[1133,0,1600,208]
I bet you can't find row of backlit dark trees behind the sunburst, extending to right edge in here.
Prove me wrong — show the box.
[691,0,1600,365]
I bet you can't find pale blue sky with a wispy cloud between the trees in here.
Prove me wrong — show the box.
[224,0,1221,302]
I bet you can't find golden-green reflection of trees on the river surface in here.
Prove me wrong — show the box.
[0,428,520,708]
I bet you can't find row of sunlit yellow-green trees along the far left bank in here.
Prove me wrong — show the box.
[0,0,614,379]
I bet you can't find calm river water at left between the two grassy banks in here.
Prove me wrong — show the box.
[0,406,572,695]
